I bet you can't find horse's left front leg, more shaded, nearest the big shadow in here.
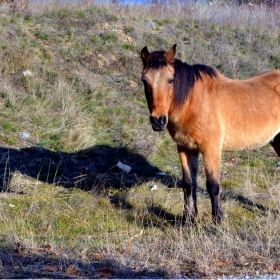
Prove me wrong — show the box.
[177,145,199,224]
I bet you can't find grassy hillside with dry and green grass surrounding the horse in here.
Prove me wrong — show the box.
[0,1,280,278]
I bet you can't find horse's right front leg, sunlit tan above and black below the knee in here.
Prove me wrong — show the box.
[202,148,223,224]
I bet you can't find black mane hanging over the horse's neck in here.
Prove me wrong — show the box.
[174,59,218,106]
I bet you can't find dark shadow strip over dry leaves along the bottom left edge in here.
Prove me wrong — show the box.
[0,247,168,279]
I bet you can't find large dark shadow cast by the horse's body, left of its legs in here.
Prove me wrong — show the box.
[0,145,166,191]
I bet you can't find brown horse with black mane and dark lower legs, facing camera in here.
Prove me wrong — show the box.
[141,45,280,223]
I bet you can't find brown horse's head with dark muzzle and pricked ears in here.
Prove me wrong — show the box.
[141,45,176,131]
